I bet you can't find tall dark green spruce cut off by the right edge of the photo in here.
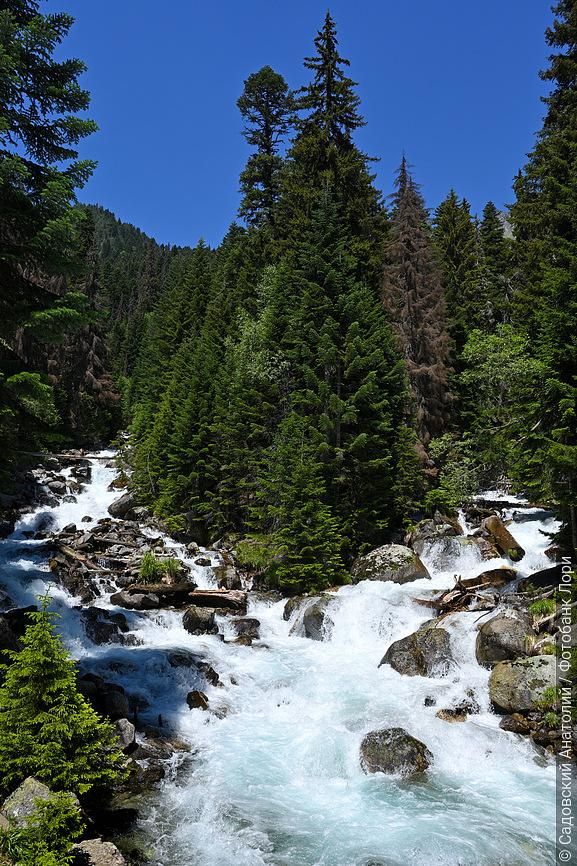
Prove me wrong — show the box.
[511,0,577,546]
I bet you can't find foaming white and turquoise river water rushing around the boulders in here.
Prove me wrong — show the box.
[0,459,556,866]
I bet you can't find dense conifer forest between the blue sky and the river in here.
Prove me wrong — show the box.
[0,0,577,590]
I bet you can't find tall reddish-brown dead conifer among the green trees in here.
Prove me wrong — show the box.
[383,157,451,446]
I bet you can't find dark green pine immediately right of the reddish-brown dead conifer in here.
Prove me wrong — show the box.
[433,190,476,357]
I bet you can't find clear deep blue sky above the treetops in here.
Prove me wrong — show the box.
[43,0,552,245]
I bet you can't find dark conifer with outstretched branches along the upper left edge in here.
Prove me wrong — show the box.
[0,0,96,460]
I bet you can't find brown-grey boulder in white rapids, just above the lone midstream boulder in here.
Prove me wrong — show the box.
[379,625,454,677]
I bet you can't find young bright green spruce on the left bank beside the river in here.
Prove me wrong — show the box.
[0,599,124,794]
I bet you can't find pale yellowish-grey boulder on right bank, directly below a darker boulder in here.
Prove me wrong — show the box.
[489,656,557,713]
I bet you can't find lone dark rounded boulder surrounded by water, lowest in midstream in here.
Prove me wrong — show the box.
[361,728,433,776]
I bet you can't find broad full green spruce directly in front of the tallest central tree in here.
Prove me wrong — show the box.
[281,190,406,553]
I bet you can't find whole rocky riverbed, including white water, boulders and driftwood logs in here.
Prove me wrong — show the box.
[0,452,560,866]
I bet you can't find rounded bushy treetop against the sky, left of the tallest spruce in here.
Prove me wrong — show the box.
[237,66,293,226]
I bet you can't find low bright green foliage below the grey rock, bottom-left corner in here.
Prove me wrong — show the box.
[0,792,84,866]
